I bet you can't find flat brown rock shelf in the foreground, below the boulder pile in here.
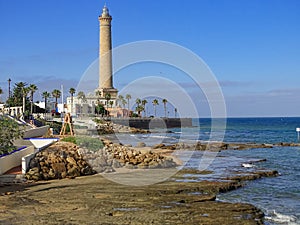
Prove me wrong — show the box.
[0,169,272,225]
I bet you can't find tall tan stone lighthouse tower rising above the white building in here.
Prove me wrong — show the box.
[98,6,118,99]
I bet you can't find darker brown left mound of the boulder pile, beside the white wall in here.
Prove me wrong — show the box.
[25,142,94,180]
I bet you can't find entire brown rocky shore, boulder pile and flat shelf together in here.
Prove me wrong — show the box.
[0,135,278,225]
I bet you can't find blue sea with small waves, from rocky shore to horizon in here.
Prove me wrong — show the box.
[120,117,300,225]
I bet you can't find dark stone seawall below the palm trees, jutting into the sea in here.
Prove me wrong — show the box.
[111,118,192,130]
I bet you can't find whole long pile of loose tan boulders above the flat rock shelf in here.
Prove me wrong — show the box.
[26,137,177,180]
